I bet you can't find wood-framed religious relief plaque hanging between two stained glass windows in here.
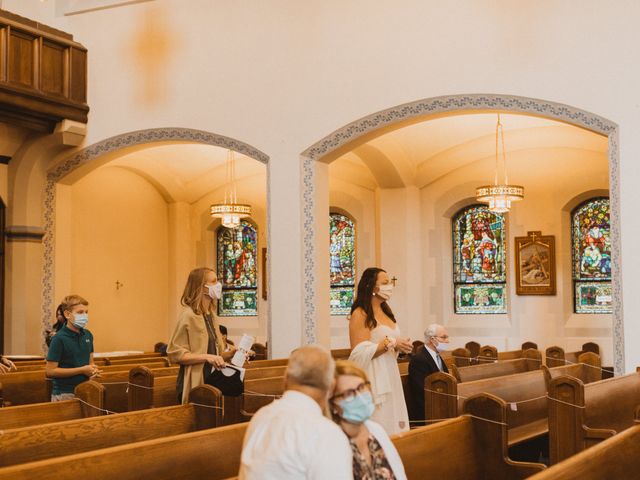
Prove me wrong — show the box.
[515,232,556,295]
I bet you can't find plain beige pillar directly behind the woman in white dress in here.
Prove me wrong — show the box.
[377,186,429,340]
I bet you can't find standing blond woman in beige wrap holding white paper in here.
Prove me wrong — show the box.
[167,268,235,403]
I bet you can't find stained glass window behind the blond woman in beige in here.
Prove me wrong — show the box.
[216,220,258,317]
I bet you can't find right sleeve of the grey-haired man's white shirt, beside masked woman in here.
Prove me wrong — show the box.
[306,425,353,480]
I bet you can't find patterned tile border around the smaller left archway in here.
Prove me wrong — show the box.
[40,128,272,352]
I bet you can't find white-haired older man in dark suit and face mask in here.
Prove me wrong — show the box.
[407,323,449,425]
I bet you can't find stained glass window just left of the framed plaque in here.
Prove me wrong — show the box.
[452,205,507,314]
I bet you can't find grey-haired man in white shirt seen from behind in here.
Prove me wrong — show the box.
[240,345,353,480]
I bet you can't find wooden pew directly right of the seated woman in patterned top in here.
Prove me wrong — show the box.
[392,395,545,480]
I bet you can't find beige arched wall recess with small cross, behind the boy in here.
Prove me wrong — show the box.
[55,167,169,352]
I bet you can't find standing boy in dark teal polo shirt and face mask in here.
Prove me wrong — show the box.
[46,295,100,402]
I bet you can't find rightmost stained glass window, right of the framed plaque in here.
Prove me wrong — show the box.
[571,197,612,313]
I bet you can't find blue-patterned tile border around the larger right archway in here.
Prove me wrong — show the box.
[301,94,624,374]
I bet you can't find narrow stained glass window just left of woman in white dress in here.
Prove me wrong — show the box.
[329,213,356,315]
